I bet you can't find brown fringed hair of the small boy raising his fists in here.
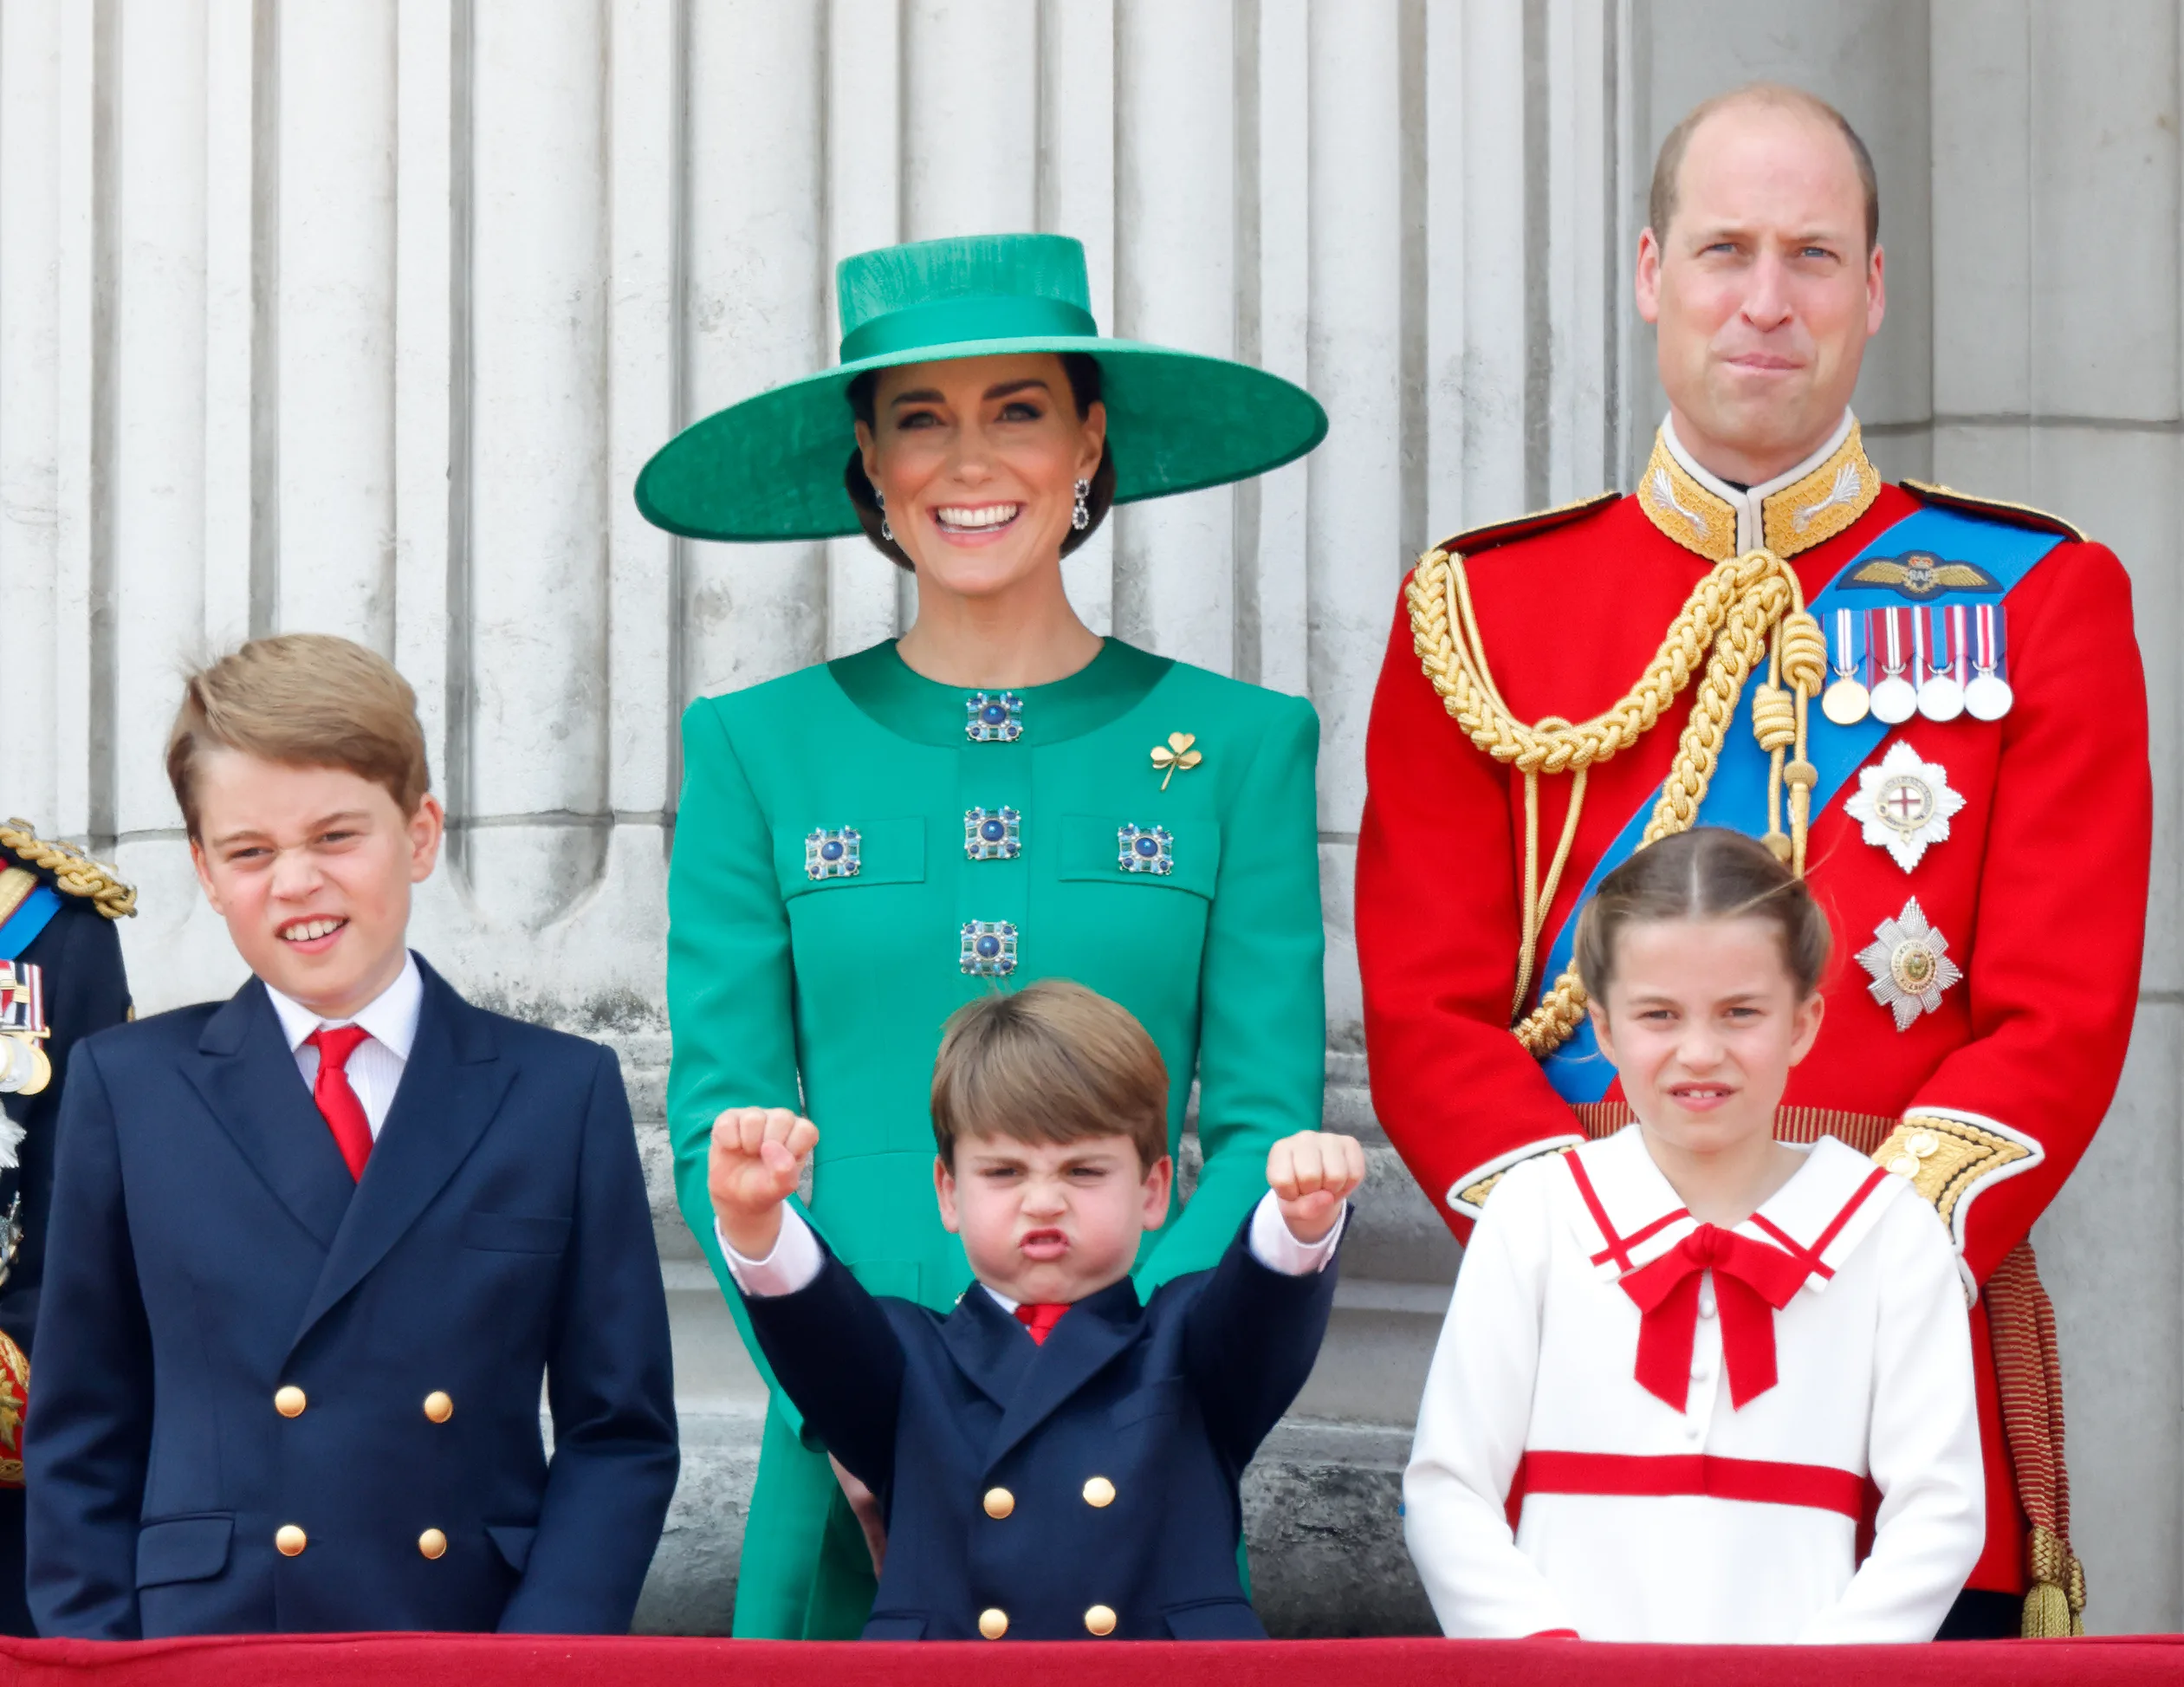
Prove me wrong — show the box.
[932,979,1169,1171]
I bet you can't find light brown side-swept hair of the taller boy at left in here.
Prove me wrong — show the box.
[166,633,432,839]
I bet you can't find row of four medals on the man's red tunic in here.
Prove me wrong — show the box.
[1819,603,2013,725]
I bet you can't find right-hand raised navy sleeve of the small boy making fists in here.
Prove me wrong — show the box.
[1183,1219,1338,1470]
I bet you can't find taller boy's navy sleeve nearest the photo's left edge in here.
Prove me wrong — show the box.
[24,1047,152,1641]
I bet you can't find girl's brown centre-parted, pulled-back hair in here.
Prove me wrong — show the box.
[1575,826,1835,1012]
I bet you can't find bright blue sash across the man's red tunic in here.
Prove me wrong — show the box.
[1539,507,2062,1106]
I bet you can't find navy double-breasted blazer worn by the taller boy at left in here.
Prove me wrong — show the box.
[24,962,677,1639]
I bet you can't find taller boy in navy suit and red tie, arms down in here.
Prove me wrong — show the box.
[24,633,677,1639]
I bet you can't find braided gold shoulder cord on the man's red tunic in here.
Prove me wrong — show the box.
[1407,548,1828,1055]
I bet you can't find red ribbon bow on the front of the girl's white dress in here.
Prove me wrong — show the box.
[1623,1223,1808,1411]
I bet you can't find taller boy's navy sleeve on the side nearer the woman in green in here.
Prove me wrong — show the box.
[500,1049,679,1634]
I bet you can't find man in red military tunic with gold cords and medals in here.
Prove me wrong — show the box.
[1357,85,2151,1639]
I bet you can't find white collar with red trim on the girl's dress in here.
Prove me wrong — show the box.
[1562,1123,1909,1294]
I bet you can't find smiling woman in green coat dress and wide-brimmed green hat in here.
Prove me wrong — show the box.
[636,234,1325,1639]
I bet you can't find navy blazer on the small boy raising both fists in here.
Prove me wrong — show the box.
[745,1219,1334,1641]
